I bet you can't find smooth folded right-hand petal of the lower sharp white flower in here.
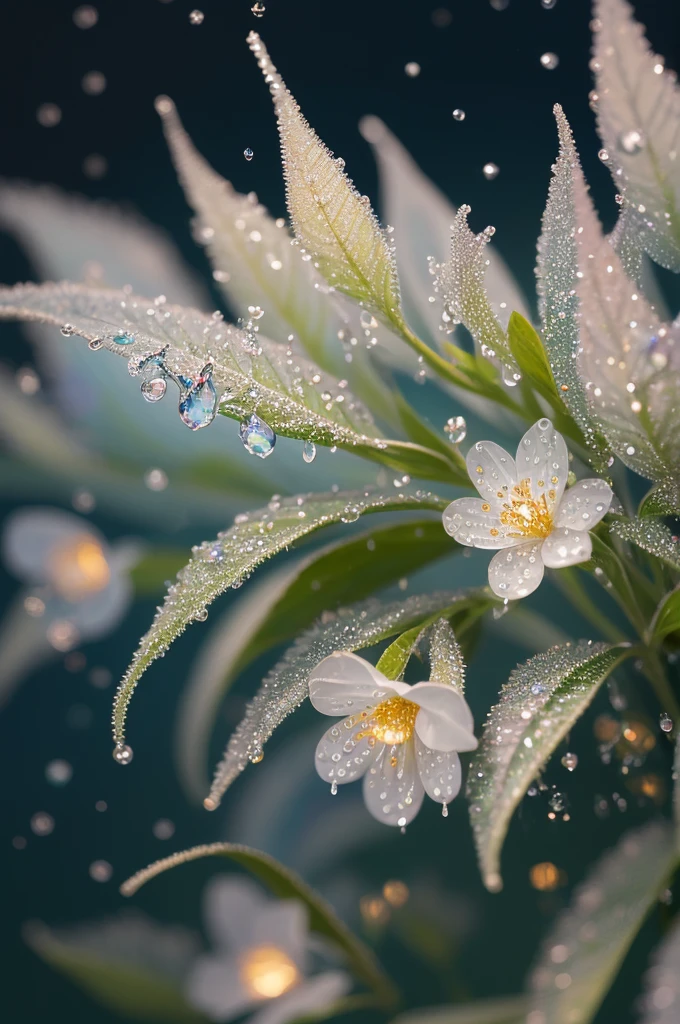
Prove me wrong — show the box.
[408,683,477,751]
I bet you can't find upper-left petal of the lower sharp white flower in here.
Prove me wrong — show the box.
[309,650,402,717]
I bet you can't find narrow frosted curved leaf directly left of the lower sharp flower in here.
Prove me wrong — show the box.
[206,590,481,810]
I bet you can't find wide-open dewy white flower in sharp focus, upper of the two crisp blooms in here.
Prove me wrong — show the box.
[442,419,613,600]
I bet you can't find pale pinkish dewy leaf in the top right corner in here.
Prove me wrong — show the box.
[592,0,680,271]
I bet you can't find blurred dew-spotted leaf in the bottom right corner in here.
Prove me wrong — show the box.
[527,822,677,1024]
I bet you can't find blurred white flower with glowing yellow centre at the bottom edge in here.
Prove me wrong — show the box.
[186,878,351,1024]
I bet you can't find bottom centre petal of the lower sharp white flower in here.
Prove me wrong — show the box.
[364,740,425,825]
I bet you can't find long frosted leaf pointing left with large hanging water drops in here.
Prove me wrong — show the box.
[0,284,456,480]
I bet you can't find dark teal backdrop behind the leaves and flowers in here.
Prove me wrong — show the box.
[0,0,680,1024]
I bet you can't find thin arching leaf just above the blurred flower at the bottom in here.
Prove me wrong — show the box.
[121,843,396,1007]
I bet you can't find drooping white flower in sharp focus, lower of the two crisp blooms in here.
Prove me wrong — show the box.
[309,651,477,825]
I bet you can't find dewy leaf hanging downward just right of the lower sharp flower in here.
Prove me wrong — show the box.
[468,640,626,892]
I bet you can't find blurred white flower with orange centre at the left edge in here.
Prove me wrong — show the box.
[2,508,139,650]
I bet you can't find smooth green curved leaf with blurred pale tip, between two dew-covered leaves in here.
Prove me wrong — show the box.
[175,519,460,800]
